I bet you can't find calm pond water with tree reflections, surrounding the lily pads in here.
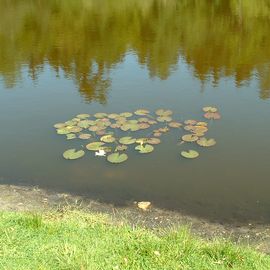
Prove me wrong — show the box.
[0,0,270,222]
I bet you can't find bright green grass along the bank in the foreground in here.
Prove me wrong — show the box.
[0,211,270,270]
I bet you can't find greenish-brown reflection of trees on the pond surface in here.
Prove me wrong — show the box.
[0,0,270,102]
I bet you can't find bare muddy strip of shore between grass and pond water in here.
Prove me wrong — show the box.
[0,184,270,254]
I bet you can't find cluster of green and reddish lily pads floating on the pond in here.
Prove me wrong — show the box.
[54,107,220,163]
